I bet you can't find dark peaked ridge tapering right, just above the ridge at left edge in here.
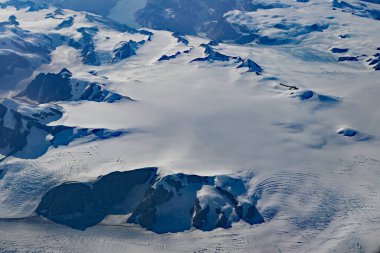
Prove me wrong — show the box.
[16,69,131,104]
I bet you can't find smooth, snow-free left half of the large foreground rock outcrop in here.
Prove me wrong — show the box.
[36,168,157,230]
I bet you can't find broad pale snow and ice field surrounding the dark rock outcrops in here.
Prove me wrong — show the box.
[0,1,380,252]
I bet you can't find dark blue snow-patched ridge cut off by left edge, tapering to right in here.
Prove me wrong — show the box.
[0,101,127,159]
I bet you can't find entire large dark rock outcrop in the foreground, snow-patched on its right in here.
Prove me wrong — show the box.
[36,168,264,233]
